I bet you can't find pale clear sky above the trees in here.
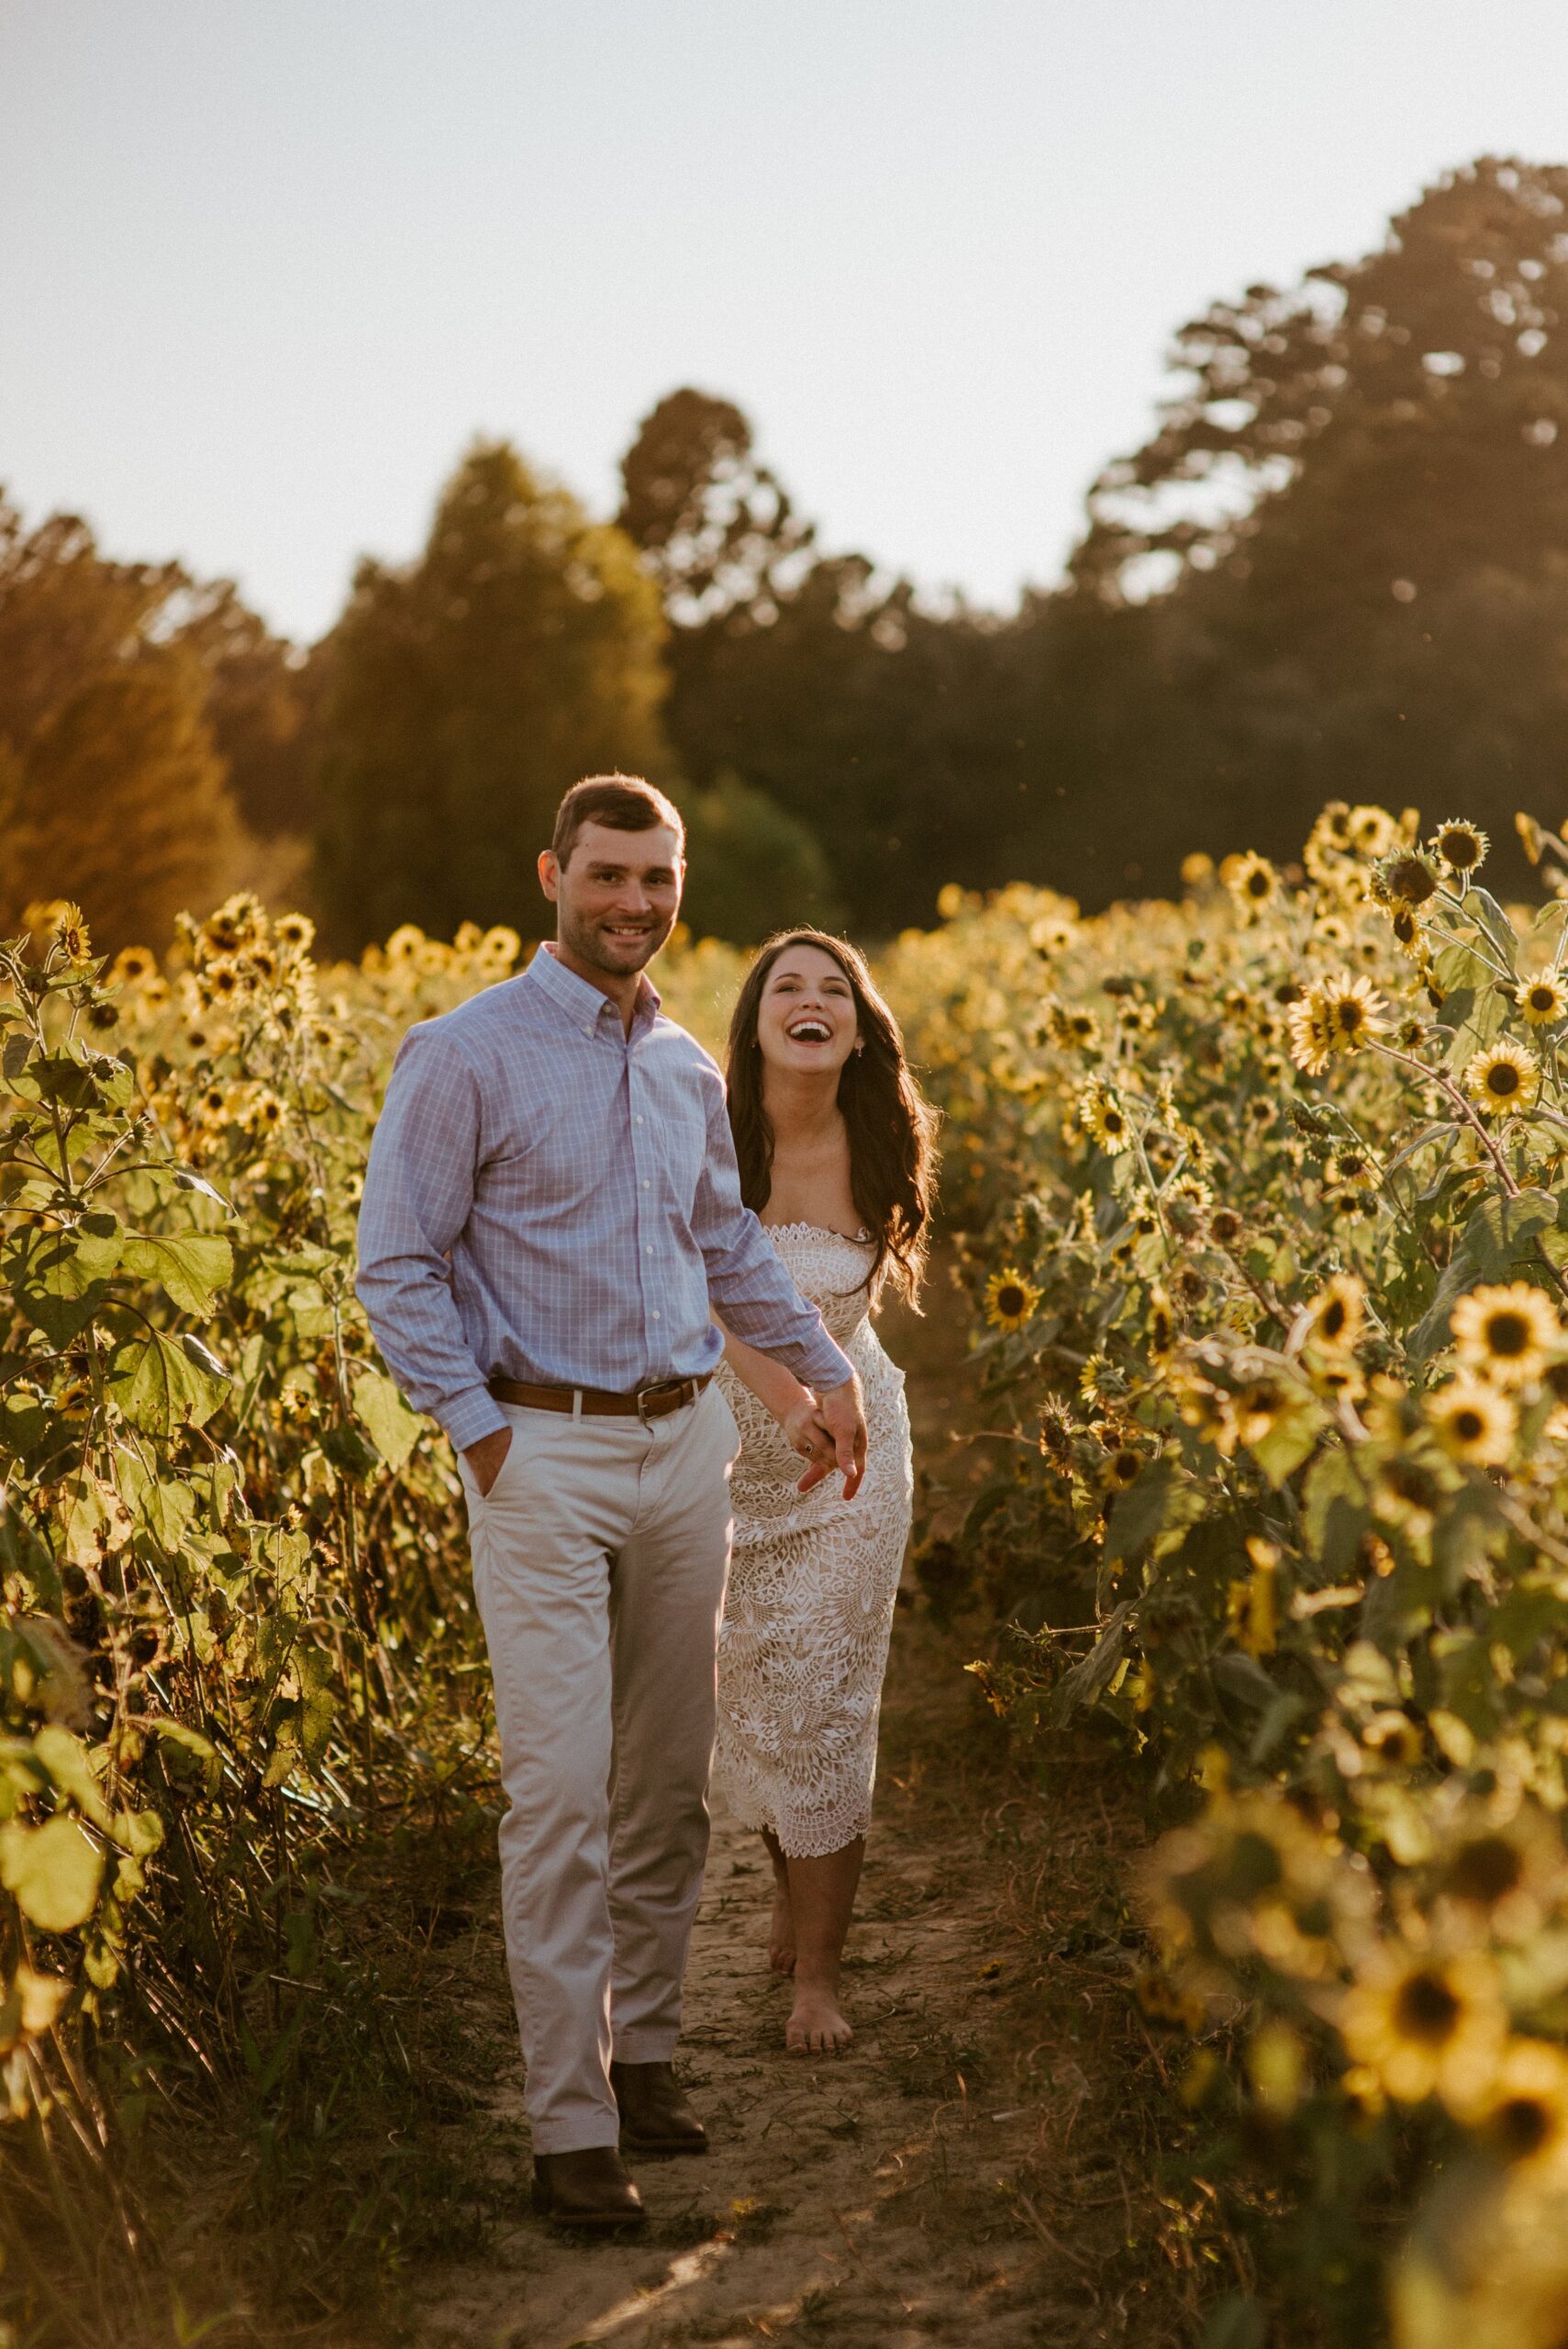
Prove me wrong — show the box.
[0,0,1568,637]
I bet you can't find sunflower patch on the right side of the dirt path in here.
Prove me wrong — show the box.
[887,806,1568,2349]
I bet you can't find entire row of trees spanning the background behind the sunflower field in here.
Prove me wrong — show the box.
[12,158,1568,949]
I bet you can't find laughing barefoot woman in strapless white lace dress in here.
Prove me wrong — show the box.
[716,930,934,2053]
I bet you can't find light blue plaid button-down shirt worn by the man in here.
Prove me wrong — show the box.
[357,949,852,1452]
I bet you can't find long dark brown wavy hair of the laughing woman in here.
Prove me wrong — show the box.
[726,930,937,1304]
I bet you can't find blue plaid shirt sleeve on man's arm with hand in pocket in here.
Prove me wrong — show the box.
[354,1027,507,1452]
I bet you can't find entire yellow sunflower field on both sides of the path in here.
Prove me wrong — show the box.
[15,806,1568,2349]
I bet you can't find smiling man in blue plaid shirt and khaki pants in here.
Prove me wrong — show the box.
[359,775,866,2227]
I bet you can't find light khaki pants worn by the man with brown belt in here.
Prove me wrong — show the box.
[462,1386,740,2154]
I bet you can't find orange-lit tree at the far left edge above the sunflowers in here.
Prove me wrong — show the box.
[0,495,247,947]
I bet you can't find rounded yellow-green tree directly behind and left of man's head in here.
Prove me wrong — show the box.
[317,441,672,947]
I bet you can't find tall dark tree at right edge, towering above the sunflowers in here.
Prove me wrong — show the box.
[1035,158,1568,881]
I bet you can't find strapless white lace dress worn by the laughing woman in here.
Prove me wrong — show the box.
[716,1224,913,1858]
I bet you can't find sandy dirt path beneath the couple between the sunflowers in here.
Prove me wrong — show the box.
[413,1297,1190,2349]
